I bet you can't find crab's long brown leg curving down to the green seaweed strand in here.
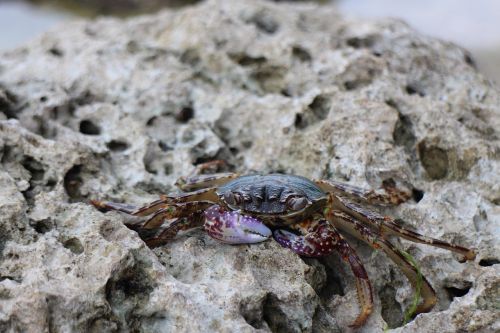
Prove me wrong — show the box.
[326,210,437,313]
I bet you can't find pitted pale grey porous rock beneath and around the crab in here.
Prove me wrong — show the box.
[0,1,500,332]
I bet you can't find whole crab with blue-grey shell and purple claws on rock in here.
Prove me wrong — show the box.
[92,161,476,327]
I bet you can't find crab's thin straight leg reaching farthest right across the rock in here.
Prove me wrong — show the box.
[333,197,476,260]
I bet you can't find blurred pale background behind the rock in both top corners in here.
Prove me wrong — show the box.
[0,0,500,84]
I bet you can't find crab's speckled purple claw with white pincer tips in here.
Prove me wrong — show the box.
[204,205,271,244]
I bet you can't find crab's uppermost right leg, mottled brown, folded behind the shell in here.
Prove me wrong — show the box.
[315,179,411,206]
